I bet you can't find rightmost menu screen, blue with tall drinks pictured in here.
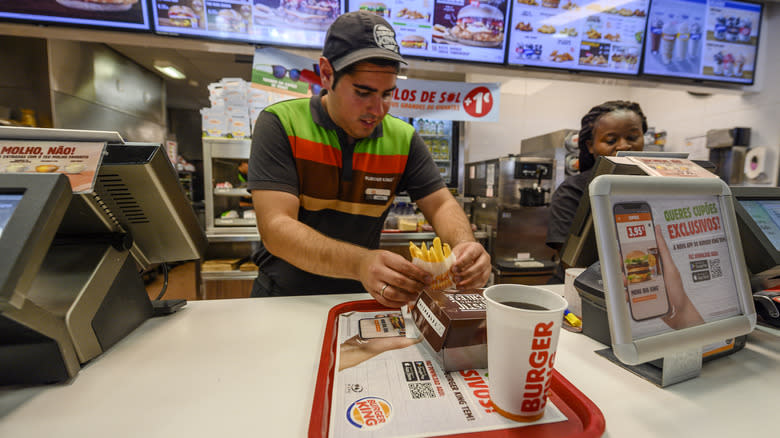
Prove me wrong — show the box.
[643,0,762,84]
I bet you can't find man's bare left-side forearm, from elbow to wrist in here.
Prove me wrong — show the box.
[260,216,369,280]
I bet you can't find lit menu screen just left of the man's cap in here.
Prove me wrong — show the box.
[152,0,344,49]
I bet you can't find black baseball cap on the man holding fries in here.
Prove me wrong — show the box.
[322,11,406,71]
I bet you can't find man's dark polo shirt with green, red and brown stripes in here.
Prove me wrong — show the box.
[248,96,444,295]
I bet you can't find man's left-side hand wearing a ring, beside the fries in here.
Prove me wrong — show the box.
[360,250,433,307]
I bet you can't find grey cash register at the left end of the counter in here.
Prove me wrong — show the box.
[0,128,207,385]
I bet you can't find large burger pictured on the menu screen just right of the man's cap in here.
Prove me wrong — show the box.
[450,4,504,46]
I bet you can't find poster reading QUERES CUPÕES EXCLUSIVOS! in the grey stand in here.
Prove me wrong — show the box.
[612,196,742,339]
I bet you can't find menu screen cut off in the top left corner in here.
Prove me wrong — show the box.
[0,0,150,30]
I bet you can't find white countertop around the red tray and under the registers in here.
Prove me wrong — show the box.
[0,288,780,438]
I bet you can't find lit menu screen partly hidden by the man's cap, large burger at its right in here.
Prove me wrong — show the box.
[349,0,509,64]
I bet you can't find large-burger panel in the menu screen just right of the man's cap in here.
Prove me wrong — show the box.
[433,0,507,51]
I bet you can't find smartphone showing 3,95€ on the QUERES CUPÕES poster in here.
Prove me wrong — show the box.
[613,202,670,321]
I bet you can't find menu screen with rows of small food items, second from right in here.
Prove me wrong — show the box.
[507,0,650,75]
